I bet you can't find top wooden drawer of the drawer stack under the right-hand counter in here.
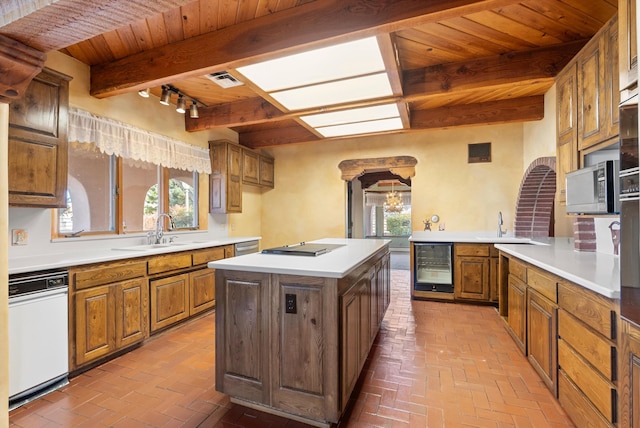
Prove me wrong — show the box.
[558,281,617,340]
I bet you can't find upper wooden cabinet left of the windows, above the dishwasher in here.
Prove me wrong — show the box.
[8,69,71,207]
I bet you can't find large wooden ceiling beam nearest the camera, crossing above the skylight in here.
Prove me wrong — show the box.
[91,0,519,98]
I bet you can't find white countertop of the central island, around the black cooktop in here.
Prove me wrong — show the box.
[209,238,391,278]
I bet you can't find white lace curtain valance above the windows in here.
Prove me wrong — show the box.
[68,109,211,174]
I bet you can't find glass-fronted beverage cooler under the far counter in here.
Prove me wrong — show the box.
[413,242,453,293]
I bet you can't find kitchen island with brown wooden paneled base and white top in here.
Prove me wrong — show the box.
[208,239,390,427]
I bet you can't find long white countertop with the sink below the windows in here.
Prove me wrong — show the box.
[9,236,260,275]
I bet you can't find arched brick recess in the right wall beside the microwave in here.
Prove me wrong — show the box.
[514,156,556,238]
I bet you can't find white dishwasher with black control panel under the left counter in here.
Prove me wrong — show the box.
[9,271,69,409]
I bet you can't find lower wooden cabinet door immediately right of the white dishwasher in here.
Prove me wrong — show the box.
[75,285,116,366]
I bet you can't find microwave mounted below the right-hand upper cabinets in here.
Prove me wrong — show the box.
[566,160,620,214]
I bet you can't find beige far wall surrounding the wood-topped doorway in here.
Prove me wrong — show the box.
[255,124,523,246]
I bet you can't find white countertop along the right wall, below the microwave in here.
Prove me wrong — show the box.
[496,238,620,299]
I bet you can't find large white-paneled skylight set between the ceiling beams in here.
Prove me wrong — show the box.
[237,37,403,137]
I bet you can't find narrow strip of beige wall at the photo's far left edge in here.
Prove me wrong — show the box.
[0,103,9,427]
